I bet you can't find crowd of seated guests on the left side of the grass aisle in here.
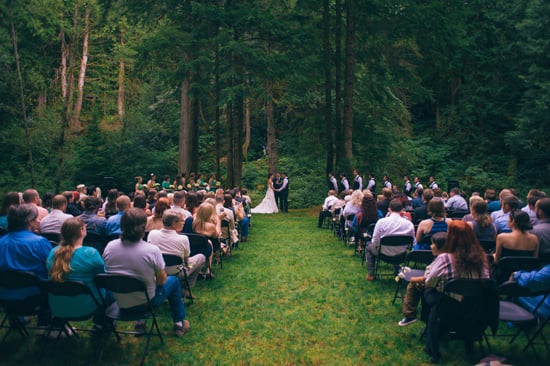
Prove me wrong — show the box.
[0,183,251,337]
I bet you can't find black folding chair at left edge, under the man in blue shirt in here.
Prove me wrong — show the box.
[0,270,47,344]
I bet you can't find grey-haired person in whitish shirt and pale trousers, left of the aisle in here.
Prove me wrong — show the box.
[147,210,206,296]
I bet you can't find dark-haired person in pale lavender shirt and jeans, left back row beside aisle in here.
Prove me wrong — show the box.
[103,208,190,337]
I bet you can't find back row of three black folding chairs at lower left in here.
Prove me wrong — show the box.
[0,270,164,365]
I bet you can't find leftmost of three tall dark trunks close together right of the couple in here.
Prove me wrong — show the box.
[323,0,334,173]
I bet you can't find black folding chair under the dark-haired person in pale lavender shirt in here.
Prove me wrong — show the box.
[94,273,164,365]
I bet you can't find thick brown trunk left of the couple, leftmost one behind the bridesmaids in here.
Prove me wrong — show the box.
[178,77,193,175]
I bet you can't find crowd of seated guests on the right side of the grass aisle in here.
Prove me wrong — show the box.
[318,171,550,362]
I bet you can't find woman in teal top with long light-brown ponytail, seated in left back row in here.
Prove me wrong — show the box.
[46,219,114,331]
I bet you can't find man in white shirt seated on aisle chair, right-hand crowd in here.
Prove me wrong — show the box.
[365,199,414,281]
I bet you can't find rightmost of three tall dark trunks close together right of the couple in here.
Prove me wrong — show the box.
[343,0,355,171]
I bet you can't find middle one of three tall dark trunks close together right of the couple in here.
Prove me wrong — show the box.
[334,0,344,169]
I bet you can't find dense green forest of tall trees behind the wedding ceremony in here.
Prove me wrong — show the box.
[0,0,550,207]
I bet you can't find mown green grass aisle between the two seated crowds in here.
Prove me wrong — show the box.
[0,210,550,365]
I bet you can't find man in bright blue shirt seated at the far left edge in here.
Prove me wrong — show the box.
[0,204,52,327]
